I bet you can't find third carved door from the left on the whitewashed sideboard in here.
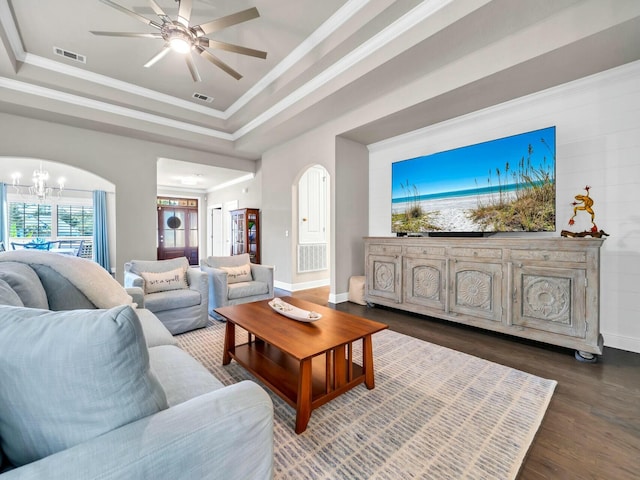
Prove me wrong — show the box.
[450,261,502,322]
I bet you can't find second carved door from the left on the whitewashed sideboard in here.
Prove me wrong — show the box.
[402,257,446,310]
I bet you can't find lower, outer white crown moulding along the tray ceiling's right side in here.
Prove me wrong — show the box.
[233,0,453,140]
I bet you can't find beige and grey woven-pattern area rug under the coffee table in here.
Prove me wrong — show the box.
[177,322,556,480]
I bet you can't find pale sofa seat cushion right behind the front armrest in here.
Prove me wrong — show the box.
[149,345,224,407]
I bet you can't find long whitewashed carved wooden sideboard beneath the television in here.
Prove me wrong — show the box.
[364,237,603,359]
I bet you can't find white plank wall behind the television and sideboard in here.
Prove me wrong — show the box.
[369,62,640,352]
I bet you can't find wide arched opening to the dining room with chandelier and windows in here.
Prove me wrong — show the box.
[0,157,115,270]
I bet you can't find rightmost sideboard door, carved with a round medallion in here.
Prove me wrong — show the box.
[513,266,586,338]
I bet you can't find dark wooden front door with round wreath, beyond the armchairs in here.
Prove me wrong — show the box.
[158,205,199,265]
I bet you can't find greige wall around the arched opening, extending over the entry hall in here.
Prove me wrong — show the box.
[0,113,255,281]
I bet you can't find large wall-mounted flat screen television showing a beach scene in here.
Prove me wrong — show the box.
[391,127,556,236]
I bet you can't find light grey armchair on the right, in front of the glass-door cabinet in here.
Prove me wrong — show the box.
[200,253,273,320]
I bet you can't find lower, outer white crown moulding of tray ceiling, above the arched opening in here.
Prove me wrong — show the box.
[0,77,233,141]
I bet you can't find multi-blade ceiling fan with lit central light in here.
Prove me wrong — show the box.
[91,0,267,82]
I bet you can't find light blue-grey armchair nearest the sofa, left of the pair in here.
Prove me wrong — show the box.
[124,257,209,335]
